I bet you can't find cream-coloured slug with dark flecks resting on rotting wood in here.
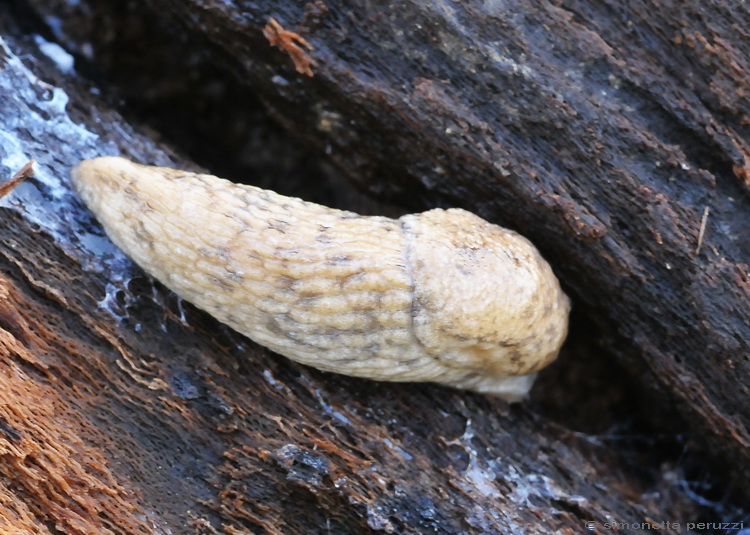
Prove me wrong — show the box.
[71,157,570,401]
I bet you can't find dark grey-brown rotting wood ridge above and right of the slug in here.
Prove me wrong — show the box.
[122,0,750,486]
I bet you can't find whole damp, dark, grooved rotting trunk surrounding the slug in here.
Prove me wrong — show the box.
[0,0,750,534]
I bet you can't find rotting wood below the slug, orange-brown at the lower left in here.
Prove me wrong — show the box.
[0,0,739,533]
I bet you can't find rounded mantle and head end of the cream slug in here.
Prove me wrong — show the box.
[401,209,570,399]
